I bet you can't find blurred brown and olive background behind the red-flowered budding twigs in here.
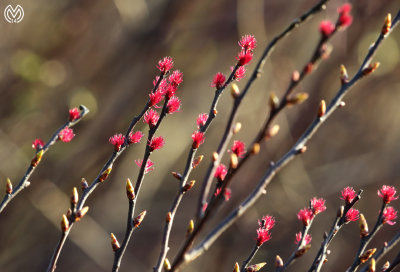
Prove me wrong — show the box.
[0,0,400,272]
